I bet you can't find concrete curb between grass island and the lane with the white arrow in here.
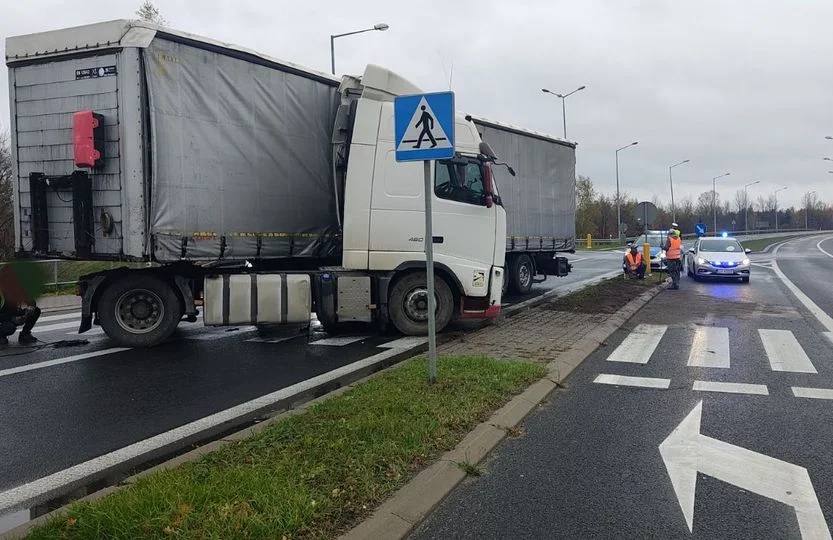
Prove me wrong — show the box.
[340,280,665,540]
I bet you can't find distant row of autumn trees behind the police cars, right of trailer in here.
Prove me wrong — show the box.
[576,175,833,238]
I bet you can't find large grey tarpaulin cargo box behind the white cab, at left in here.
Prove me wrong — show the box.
[6,21,340,263]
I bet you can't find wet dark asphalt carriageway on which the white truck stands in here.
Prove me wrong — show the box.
[0,253,621,531]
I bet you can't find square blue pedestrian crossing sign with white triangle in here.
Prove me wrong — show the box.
[393,92,454,161]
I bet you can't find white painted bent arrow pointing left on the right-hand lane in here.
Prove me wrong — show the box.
[659,401,830,540]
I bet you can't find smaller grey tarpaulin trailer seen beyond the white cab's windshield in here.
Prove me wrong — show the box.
[471,116,576,293]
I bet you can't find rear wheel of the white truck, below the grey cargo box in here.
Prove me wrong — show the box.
[97,275,182,347]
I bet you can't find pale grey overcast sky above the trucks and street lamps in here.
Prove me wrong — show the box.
[0,0,833,207]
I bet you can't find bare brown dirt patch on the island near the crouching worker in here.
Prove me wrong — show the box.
[541,276,659,314]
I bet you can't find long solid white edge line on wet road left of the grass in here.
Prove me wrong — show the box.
[0,349,414,513]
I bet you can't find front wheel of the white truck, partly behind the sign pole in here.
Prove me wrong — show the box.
[388,272,454,336]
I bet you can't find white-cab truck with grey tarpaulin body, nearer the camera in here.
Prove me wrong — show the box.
[1,20,565,347]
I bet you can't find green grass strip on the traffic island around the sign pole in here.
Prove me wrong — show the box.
[29,357,545,540]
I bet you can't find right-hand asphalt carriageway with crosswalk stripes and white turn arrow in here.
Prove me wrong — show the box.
[413,238,833,540]
